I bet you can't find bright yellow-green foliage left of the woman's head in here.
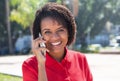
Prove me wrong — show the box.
[10,0,47,28]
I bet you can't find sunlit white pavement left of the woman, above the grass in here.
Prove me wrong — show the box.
[0,55,31,77]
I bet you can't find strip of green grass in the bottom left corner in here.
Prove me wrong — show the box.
[0,73,22,81]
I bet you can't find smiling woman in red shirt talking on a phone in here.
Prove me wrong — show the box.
[22,3,93,81]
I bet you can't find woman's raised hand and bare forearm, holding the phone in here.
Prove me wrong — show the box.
[32,37,48,81]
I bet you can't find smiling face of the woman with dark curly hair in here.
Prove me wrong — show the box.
[40,17,68,54]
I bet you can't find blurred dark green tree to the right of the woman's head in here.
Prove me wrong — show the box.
[76,0,120,48]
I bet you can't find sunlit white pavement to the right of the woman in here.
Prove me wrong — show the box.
[87,54,120,81]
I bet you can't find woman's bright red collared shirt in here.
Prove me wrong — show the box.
[22,50,93,81]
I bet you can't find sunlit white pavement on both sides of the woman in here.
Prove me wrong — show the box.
[0,54,120,81]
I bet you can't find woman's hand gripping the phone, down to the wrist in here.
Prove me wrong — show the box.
[32,37,48,64]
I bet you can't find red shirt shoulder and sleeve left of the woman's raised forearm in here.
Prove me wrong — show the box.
[22,56,38,81]
